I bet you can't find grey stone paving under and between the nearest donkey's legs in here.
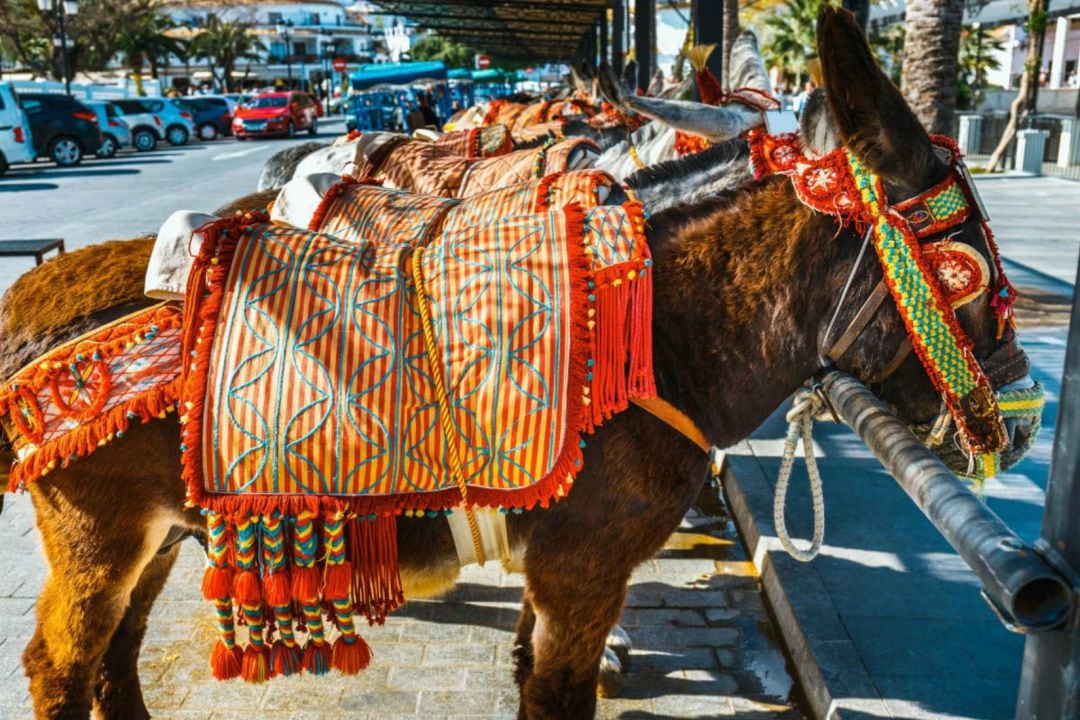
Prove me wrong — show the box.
[0,490,801,720]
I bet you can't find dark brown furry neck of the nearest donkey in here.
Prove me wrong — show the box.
[649,178,849,447]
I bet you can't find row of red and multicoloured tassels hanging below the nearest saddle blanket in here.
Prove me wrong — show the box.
[202,511,404,682]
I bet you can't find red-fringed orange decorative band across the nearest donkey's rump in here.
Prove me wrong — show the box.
[0,303,181,491]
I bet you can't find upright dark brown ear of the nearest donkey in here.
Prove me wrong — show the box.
[818,6,941,193]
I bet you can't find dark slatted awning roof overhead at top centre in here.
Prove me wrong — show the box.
[368,0,609,60]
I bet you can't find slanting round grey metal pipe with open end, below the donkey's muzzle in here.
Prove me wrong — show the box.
[822,370,1075,629]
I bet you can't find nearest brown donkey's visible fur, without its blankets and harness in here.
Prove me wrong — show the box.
[0,9,1026,719]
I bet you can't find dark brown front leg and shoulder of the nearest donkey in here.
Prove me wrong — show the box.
[513,409,705,720]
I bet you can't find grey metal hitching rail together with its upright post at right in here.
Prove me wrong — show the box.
[822,262,1080,720]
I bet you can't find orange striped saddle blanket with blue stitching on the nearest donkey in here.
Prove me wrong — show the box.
[185,184,654,515]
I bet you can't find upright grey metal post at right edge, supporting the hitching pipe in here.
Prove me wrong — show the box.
[1016,255,1080,720]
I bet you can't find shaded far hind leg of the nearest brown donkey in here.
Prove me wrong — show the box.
[94,543,180,720]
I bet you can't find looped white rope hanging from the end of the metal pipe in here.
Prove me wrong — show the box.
[772,389,825,562]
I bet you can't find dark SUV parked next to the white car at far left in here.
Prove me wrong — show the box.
[18,93,102,167]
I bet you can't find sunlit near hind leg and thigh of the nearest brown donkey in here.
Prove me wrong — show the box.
[23,422,190,720]
